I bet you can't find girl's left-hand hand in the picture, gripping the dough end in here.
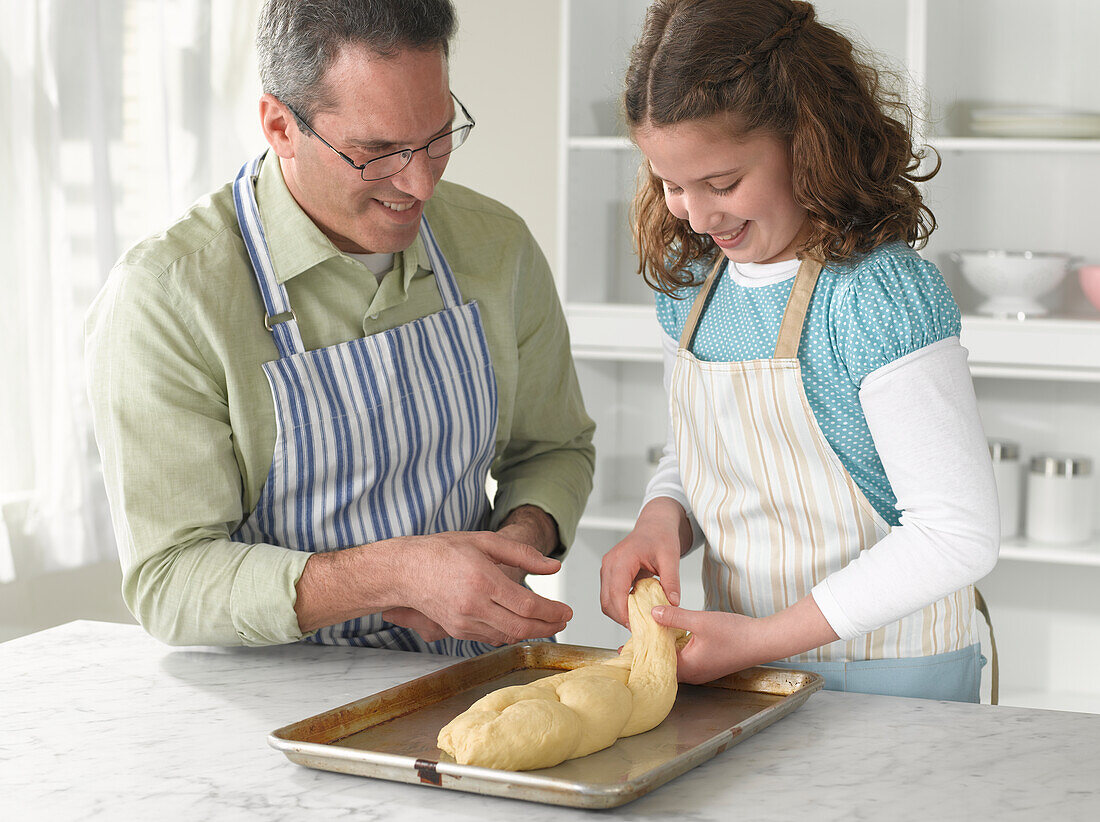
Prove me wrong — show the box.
[600,497,691,628]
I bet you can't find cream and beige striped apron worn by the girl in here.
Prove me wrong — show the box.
[670,257,978,662]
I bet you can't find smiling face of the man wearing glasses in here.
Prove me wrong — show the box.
[282,45,454,253]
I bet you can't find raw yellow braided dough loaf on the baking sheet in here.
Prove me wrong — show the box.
[438,578,686,770]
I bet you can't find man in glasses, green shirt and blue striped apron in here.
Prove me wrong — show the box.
[86,0,594,656]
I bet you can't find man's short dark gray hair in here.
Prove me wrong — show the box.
[256,0,458,121]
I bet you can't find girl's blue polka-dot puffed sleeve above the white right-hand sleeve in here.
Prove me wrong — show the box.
[829,244,960,385]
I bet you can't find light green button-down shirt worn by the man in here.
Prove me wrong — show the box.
[86,150,594,645]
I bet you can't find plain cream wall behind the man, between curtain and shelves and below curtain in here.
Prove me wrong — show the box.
[0,0,560,642]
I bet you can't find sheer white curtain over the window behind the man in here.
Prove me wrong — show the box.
[0,0,264,582]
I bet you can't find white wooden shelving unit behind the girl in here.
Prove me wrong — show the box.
[558,0,1100,711]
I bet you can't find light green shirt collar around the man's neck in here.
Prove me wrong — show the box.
[256,152,431,293]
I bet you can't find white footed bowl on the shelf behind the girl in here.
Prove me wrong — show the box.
[952,250,1074,317]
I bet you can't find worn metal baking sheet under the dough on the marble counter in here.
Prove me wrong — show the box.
[267,643,824,808]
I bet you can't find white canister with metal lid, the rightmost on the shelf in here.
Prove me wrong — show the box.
[1027,453,1093,545]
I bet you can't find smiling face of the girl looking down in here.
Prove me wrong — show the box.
[635,119,809,263]
